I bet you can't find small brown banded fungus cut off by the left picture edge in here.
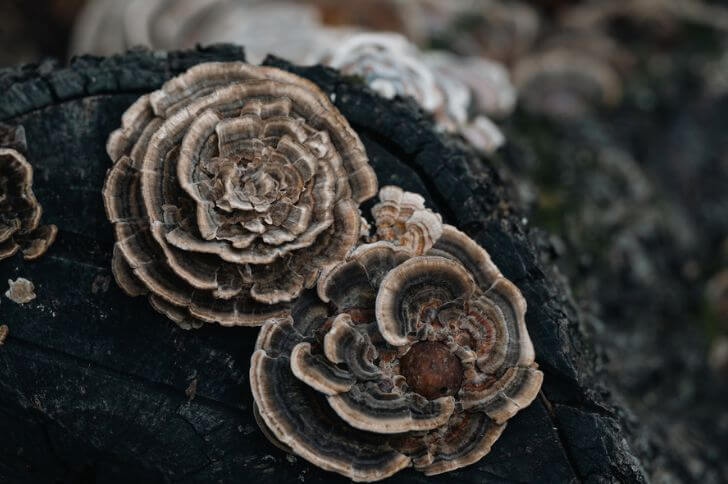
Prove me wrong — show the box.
[0,124,58,260]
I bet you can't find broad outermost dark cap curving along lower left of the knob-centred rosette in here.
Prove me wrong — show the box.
[250,292,410,481]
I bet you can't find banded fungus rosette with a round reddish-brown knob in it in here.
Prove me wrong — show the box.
[250,225,543,481]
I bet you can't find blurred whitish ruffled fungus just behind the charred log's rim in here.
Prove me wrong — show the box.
[322,33,505,152]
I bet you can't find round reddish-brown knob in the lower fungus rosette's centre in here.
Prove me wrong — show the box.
[400,341,463,400]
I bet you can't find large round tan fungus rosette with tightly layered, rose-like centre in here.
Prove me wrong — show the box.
[103,62,377,327]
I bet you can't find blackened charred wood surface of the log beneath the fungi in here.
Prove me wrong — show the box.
[0,45,645,483]
